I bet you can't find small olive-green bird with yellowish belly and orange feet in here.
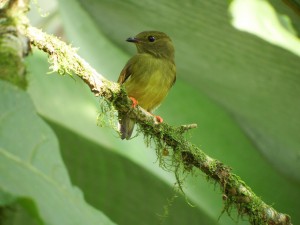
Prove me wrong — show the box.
[118,31,176,139]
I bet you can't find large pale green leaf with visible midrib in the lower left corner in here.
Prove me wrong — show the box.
[0,81,114,225]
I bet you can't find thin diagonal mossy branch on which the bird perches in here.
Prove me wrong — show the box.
[26,27,292,225]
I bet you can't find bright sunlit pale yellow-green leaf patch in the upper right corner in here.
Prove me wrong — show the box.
[230,0,300,56]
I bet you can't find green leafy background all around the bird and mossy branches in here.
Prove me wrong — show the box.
[0,0,300,225]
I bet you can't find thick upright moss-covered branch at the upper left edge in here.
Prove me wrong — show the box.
[0,0,29,89]
